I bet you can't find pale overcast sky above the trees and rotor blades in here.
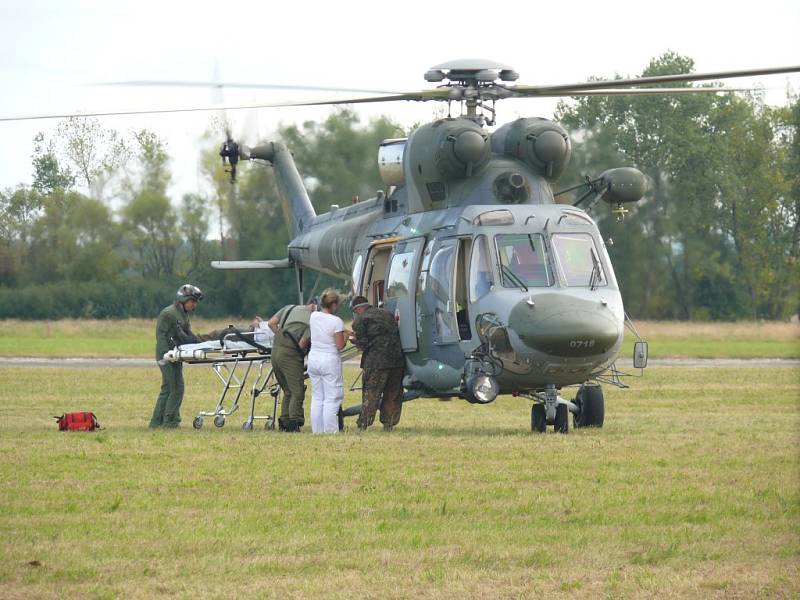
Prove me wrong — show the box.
[0,0,800,204]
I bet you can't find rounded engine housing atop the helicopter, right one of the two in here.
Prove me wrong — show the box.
[492,117,572,181]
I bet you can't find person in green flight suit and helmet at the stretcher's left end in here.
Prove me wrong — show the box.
[150,283,203,428]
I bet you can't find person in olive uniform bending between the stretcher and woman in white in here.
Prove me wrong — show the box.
[267,304,317,431]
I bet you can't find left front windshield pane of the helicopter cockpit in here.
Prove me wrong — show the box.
[495,233,553,288]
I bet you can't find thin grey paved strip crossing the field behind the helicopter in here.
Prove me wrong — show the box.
[0,357,800,369]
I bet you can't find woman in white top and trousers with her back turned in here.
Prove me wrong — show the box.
[308,290,347,433]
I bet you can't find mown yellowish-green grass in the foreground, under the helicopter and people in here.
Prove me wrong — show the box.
[0,367,800,599]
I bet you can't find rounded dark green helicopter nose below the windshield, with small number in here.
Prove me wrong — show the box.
[509,296,622,358]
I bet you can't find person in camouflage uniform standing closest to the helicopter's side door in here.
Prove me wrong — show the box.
[351,296,405,431]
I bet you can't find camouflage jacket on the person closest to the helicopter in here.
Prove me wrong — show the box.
[353,306,406,369]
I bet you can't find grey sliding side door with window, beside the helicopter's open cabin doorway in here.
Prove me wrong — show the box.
[384,238,425,352]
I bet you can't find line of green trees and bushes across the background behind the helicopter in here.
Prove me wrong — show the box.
[0,53,800,320]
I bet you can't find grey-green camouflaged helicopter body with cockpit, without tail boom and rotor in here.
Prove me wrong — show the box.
[276,117,624,396]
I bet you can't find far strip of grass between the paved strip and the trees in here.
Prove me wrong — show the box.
[0,319,800,358]
